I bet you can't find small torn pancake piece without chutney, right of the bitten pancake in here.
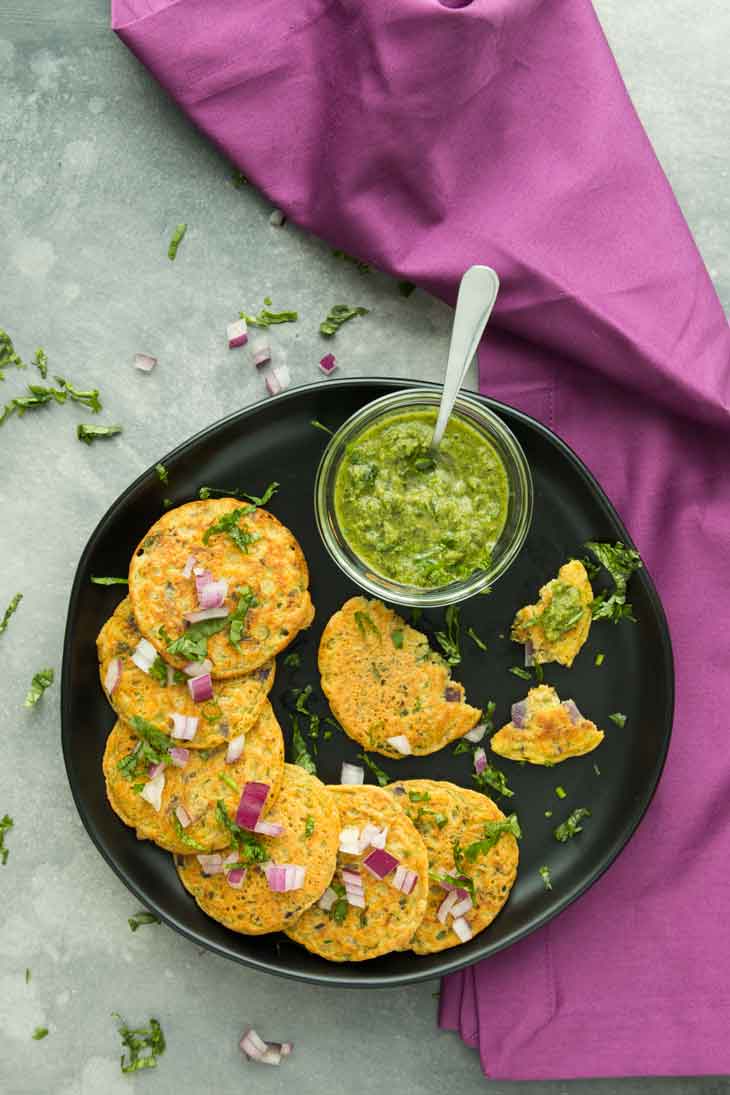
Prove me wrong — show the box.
[490,684,604,764]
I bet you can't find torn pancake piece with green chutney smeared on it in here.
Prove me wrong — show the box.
[512,558,593,668]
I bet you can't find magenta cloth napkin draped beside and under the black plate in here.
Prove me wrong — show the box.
[113,0,730,1079]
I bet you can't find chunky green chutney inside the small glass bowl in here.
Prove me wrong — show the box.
[335,408,509,589]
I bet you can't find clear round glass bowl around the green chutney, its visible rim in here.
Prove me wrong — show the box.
[314,388,532,608]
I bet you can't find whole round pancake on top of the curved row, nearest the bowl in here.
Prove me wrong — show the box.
[129,498,314,677]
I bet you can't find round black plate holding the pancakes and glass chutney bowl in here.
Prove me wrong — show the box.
[61,380,674,987]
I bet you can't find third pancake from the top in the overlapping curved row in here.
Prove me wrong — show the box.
[103,701,283,853]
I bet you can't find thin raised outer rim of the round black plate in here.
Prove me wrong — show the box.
[60,377,675,989]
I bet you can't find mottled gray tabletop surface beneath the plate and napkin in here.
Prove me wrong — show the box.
[0,0,730,1095]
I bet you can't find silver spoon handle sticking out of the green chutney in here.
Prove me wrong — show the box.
[431,266,499,449]
